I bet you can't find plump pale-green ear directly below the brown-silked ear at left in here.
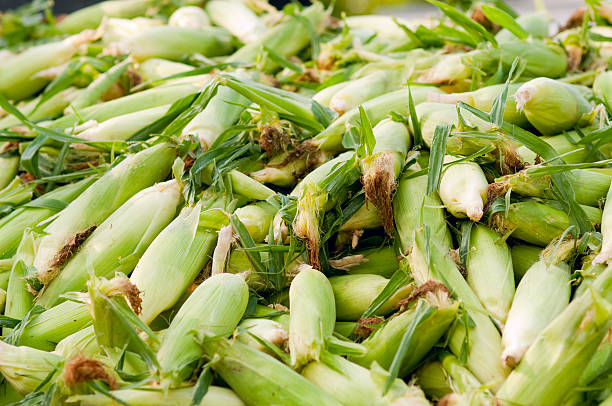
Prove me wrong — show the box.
[37,180,181,307]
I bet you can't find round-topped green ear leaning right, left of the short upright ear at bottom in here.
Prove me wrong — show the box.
[157,274,249,386]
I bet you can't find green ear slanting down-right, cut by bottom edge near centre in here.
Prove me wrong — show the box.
[204,339,341,406]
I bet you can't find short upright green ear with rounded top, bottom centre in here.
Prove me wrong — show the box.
[289,266,336,368]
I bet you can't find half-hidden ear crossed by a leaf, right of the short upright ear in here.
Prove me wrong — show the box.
[329,274,414,321]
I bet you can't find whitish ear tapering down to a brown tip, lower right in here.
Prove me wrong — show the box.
[501,260,570,368]
